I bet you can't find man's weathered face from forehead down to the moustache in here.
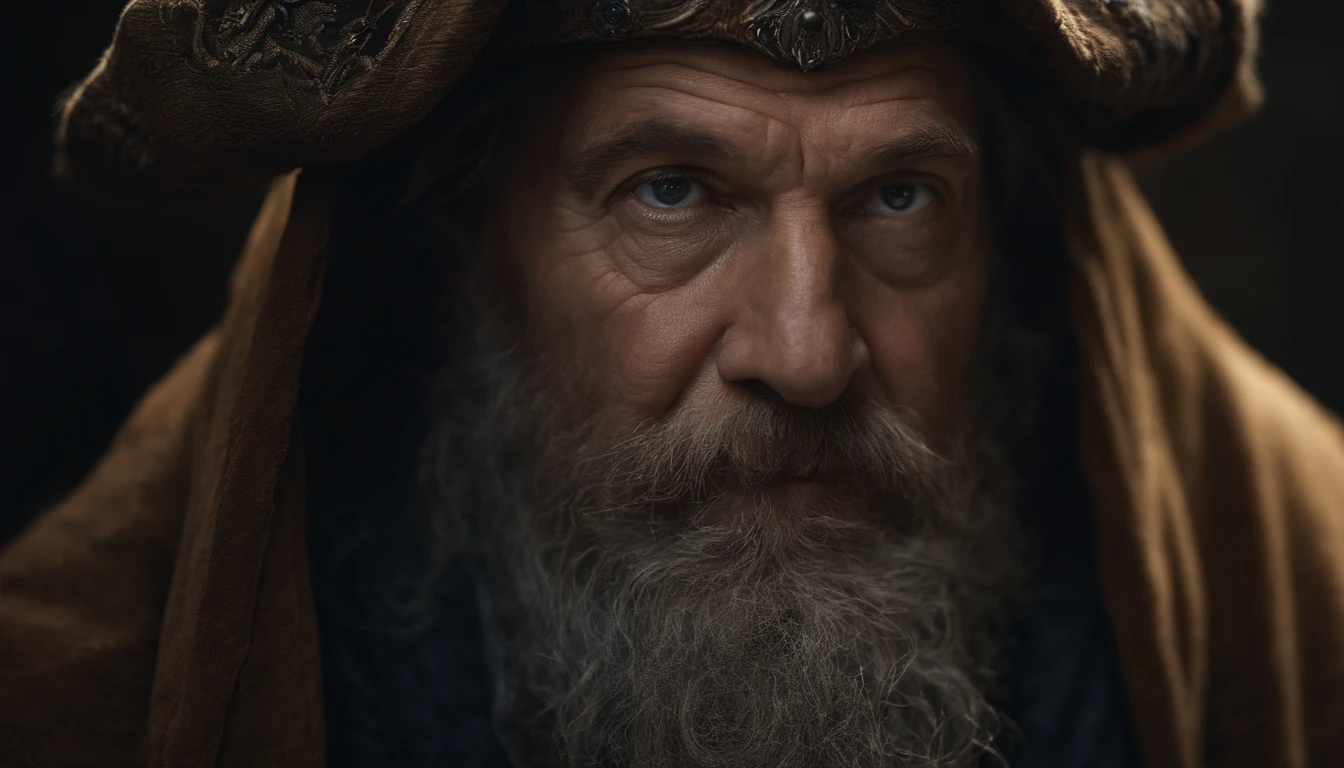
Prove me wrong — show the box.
[487,40,991,448]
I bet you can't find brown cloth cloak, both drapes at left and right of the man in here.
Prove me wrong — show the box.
[0,153,1344,768]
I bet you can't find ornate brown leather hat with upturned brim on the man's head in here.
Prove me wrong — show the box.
[59,0,1259,206]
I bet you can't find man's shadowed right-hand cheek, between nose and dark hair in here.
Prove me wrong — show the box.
[853,225,989,438]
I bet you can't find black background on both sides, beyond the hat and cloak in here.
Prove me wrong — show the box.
[0,0,1344,541]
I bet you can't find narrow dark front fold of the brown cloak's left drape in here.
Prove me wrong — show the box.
[145,172,331,767]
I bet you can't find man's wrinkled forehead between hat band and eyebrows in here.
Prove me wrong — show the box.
[546,39,976,153]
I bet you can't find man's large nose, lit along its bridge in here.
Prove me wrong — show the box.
[718,208,868,408]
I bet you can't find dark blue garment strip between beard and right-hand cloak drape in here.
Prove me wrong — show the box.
[1000,340,1137,768]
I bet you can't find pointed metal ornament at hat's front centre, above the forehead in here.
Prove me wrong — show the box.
[747,0,872,71]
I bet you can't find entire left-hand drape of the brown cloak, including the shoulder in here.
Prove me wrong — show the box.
[0,176,331,768]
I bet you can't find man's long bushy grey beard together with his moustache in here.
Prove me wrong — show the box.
[426,306,1021,768]
